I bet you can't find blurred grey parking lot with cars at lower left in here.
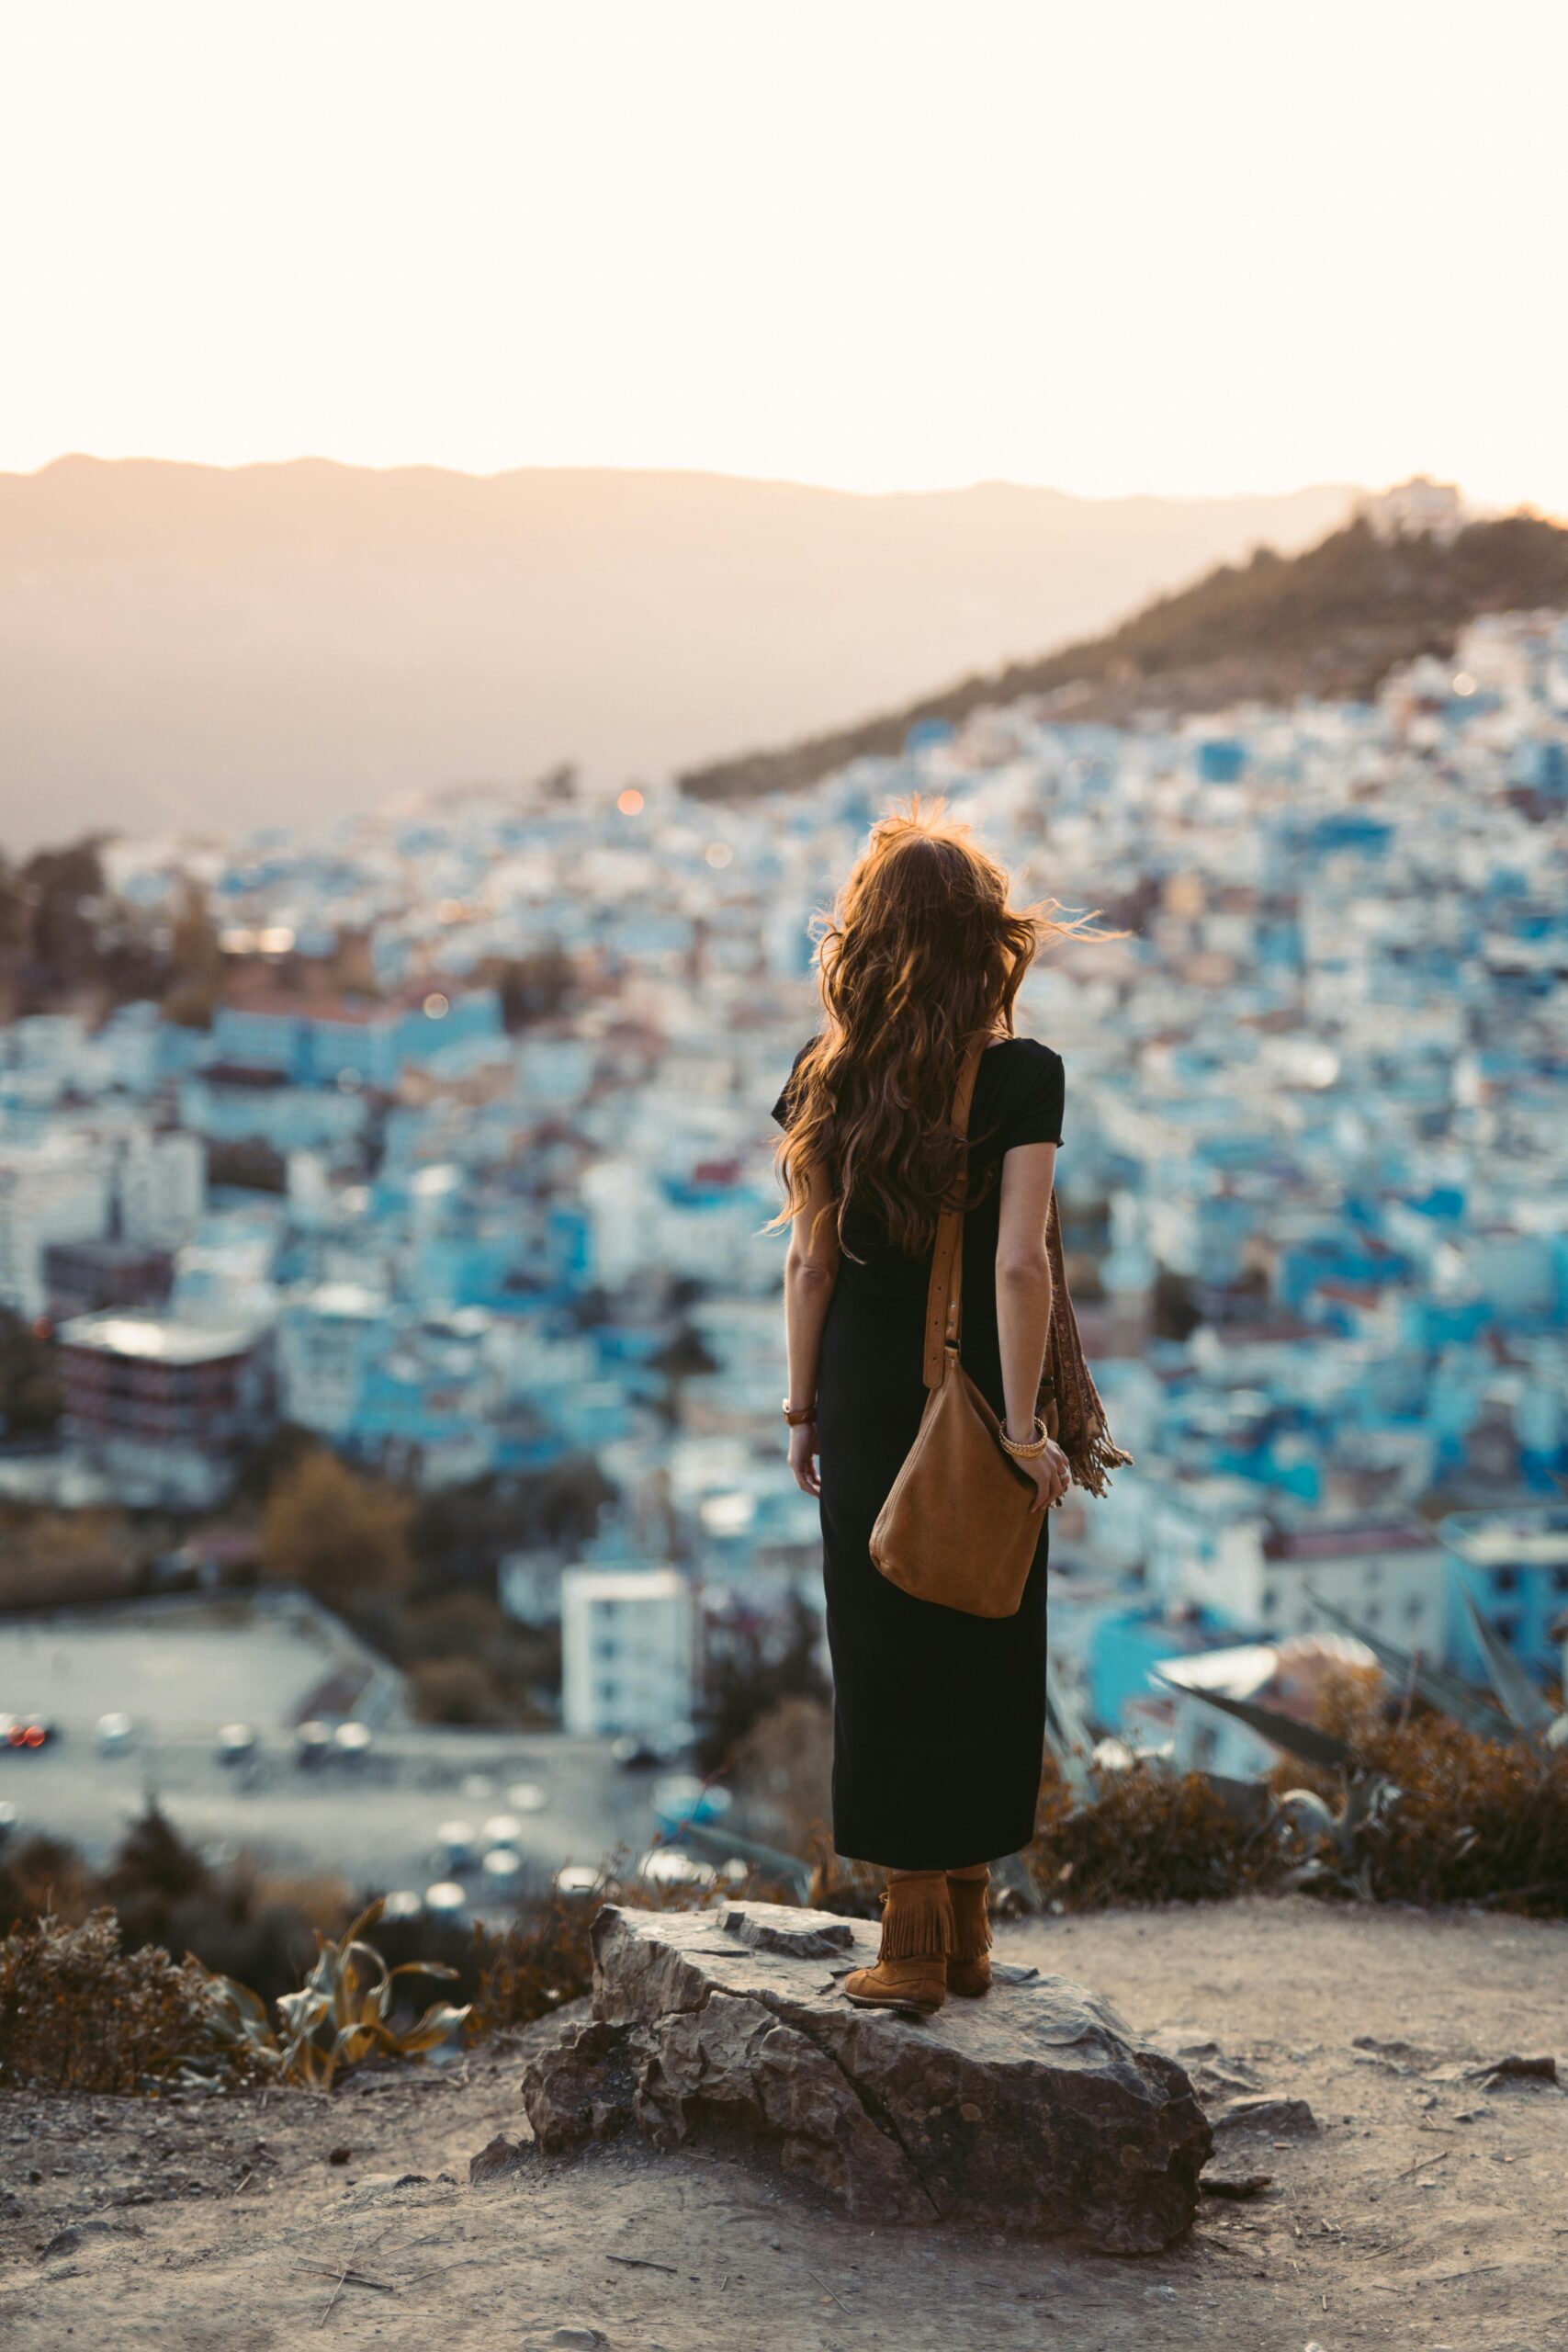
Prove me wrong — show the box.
[0,1601,677,1907]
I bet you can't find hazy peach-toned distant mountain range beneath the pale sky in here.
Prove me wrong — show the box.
[0,457,1352,847]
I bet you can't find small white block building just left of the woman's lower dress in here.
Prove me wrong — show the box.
[562,1566,696,1738]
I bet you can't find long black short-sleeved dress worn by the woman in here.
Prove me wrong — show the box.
[773,1037,1065,1870]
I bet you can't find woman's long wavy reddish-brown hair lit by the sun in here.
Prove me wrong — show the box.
[776,799,1112,1256]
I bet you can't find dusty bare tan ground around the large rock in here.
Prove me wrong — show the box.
[0,1898,1568,2352]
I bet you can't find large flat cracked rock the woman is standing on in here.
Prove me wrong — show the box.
[525,1903,1211,2253]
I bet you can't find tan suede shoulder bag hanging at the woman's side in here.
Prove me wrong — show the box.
[872,1045,1042,1616]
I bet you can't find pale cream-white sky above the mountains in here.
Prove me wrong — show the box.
[0,0,1568,513]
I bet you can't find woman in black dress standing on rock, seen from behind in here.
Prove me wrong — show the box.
[773,802,1090,2013]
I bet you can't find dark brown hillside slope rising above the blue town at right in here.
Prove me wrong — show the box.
[680,515,1568,799]
